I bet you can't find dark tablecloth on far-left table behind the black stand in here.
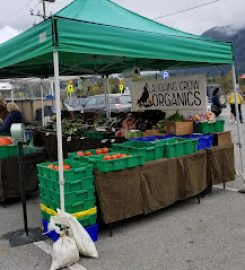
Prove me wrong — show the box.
[0,153,45,201]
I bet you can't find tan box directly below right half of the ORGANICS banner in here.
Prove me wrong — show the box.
[166,121,193,135]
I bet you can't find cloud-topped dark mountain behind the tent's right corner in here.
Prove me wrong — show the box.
[202,25,245,74]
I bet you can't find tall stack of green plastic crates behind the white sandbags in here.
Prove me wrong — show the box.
[37,159,97,227]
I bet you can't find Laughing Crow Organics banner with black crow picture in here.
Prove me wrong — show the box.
[131,75,207,113]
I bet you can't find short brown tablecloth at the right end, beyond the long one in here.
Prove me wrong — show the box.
[207,144,236,186]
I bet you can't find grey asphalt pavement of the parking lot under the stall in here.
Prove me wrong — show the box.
[0,109,245,270]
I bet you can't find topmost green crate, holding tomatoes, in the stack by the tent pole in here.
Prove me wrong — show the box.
[37,159,93,183]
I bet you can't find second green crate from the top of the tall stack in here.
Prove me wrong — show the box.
[38,175,94,192]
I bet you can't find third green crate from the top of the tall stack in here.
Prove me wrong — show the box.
[38,184,95,205]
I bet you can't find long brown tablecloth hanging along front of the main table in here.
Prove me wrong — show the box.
[95,151,208,224]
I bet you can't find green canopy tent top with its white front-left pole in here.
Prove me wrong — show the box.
[0,0,243,209]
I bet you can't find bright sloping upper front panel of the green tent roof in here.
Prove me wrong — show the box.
[55,0,195,37]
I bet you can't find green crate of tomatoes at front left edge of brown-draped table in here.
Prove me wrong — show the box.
[75,151,145,173]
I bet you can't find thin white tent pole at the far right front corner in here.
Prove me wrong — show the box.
[232,64,245,193]
